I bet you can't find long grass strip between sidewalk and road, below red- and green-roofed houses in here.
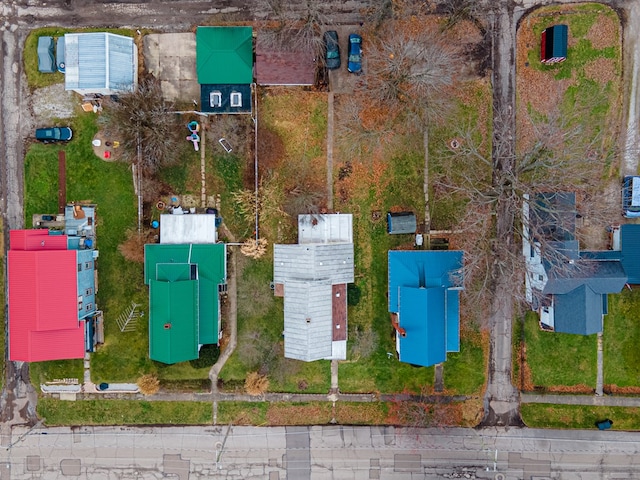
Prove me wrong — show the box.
[38,398,213,426]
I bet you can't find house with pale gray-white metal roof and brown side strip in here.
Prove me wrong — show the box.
[273,214,354,362]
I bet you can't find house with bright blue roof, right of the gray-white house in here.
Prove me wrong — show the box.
[388,250,463,367]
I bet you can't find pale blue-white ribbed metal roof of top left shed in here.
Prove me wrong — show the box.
[64,32,138,95]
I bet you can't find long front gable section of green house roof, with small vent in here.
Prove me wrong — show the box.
[149,280,198,364]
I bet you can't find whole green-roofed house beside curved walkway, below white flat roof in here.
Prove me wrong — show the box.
[144,243,227,364]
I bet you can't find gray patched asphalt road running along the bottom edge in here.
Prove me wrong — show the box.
[0,426,640,480]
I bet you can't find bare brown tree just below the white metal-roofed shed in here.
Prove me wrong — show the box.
[100,76,186,173]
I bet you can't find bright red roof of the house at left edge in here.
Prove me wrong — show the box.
[8,230,85,362]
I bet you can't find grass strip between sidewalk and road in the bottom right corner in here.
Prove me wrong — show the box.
[520,403,640,430]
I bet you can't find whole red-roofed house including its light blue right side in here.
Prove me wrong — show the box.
[7,204,98,362]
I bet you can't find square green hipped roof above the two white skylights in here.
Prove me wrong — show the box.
[196,27,253,85]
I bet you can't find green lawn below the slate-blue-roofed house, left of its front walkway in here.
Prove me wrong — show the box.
[525,312,596,388]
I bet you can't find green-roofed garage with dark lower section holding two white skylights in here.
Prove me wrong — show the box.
[196,27,254,113]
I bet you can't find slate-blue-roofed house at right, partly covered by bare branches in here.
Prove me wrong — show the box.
[522,192,628,335]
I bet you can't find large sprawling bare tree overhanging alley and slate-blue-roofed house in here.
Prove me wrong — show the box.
[435,102,616,316]
